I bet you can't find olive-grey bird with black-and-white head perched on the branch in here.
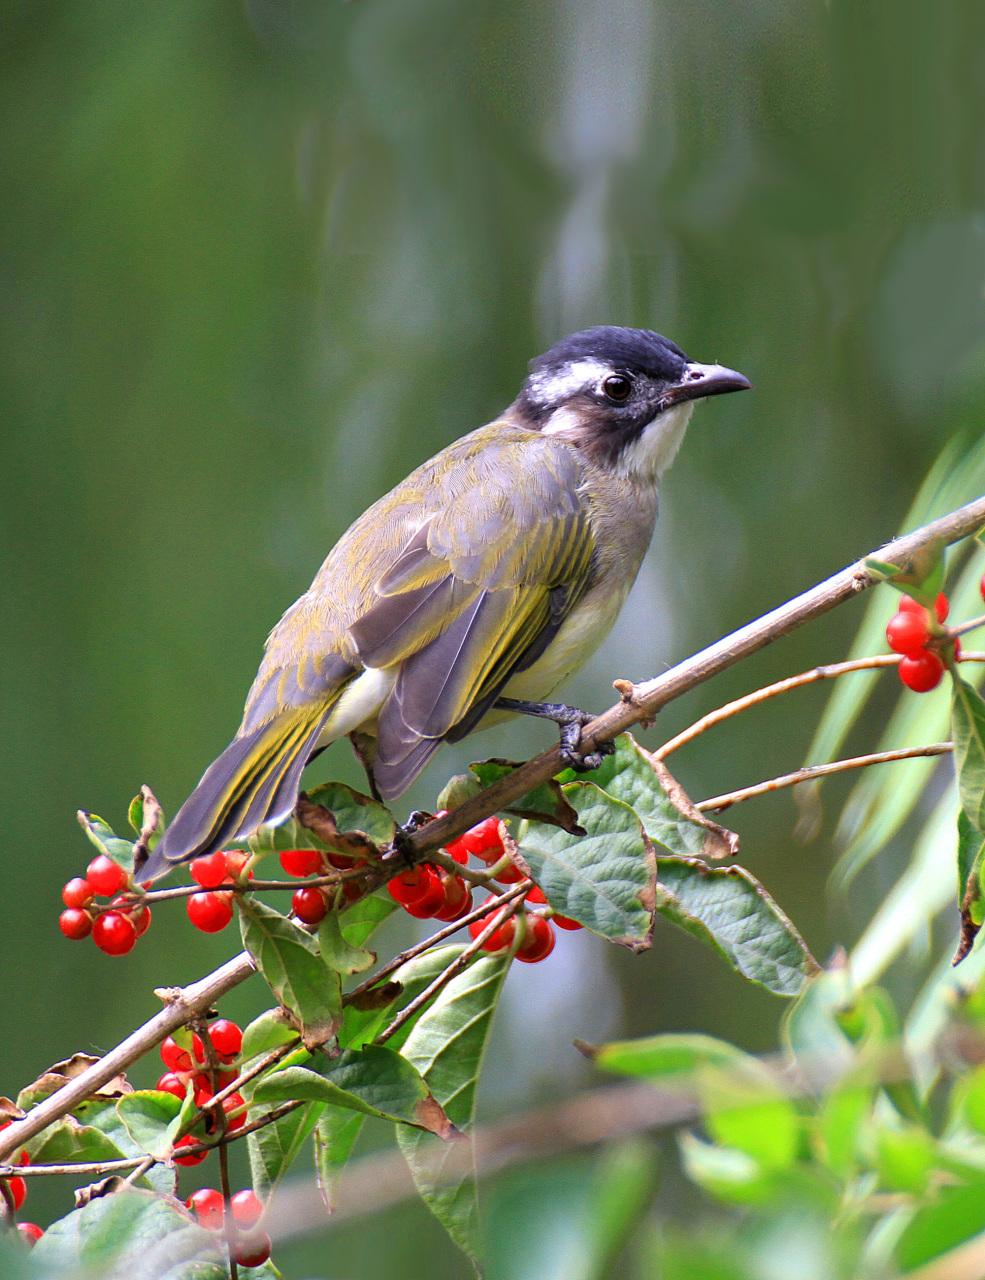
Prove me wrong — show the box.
[136,325,752,883]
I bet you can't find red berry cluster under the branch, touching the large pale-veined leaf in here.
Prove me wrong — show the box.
[388,814,581,964]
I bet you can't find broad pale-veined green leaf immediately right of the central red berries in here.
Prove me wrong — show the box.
[518,782,654,951]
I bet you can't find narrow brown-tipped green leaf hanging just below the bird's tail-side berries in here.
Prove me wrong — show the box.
[239,899,342,1048]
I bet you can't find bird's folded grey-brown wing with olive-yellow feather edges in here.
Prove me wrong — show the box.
[348,433,594,797]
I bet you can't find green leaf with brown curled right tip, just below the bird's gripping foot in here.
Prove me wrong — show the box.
[562,733,738,858]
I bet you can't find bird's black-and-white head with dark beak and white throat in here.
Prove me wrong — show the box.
[512,325,752,484]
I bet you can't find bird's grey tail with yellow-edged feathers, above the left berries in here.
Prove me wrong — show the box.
[136,703,331,884]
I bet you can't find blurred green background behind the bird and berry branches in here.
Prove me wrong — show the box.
[0,0,985,1280]
